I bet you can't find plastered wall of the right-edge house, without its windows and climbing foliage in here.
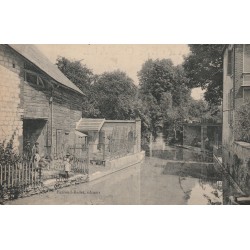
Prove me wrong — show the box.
[223,44,250,195]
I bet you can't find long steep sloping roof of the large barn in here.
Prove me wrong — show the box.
[9,44,84,95]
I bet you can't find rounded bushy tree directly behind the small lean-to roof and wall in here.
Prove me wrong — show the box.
[93,70,137,119]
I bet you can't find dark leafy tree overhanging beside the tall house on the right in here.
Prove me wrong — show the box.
[183,44,224,105]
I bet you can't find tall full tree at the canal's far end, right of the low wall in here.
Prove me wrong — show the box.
[138,59,190,141]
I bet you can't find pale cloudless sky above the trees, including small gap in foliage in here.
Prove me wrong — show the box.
[36,44,202,99]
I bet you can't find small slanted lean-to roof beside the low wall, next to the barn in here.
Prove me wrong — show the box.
[76,118,105,133]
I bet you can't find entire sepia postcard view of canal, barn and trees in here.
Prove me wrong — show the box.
[0,44,250,205]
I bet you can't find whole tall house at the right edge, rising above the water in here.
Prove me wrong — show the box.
[222,44,250,197]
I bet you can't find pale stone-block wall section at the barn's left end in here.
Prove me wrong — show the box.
[0,45,23,152]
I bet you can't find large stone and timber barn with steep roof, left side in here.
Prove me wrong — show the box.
[0,45,84,159]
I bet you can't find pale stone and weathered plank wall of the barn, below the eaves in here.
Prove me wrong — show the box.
[0,45,82,158]
